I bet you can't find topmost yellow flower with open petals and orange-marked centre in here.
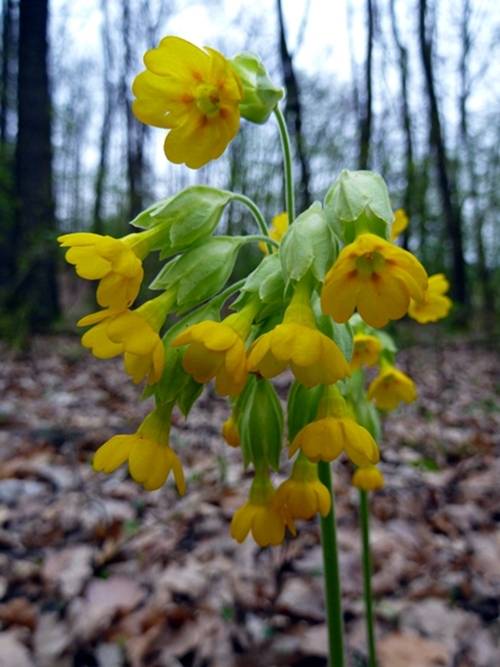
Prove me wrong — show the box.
[132,37,242,169]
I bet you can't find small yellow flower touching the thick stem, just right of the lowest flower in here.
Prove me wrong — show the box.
[274,455,332,519]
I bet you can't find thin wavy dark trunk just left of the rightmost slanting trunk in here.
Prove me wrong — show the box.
[390,0,417,248]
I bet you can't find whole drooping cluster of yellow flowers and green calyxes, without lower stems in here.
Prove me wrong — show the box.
[59,37,451,547]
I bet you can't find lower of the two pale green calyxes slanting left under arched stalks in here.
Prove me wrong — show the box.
[150,236,245,309]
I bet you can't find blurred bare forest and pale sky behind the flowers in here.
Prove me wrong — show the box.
[0,0,500,336]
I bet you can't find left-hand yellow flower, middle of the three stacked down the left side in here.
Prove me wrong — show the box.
[77,291,175,384]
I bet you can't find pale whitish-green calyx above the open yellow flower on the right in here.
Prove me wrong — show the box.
[325,169,394,243]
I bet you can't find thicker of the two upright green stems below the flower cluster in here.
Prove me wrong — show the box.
[318,461,344,667]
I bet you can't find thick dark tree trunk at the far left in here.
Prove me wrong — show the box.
[13,0,59,331]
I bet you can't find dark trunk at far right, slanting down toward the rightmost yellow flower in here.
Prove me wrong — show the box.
[419,0,467,305]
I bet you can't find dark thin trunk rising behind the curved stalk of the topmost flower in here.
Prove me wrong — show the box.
[276,0,311,212]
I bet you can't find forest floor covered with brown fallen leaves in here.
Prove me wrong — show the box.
[0,335,500,667]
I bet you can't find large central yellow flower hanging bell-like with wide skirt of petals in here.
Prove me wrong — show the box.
[248,283,350,387]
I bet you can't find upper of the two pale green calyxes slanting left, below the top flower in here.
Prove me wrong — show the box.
[132,185,234,257]
